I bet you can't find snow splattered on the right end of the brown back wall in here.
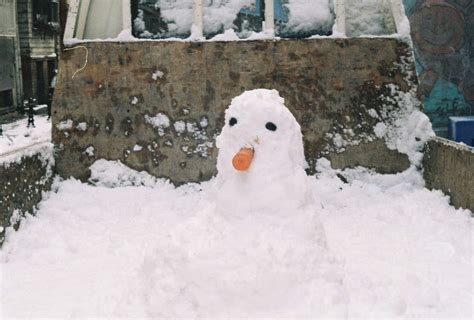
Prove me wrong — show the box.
[324,54,435,167]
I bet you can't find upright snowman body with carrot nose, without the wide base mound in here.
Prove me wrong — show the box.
[215,89,325,243]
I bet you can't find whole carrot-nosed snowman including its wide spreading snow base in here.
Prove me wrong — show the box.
[121,89,346,318]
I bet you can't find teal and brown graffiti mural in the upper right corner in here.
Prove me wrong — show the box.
[403,0,474,136]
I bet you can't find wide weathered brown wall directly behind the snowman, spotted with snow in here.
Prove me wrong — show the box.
[53,38,417,184]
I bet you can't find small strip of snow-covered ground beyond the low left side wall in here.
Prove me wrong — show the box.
[0,116,51,156]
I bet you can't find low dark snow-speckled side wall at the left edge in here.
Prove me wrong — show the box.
[0,143,54,246]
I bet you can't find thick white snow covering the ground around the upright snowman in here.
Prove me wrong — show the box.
[0,159,473,319]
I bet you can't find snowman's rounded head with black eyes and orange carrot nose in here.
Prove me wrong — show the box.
[216,89,306,180]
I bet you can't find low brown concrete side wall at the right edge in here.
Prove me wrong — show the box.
[423,137,474,212]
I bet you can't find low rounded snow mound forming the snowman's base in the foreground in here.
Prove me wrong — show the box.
[116,208,346,318]
